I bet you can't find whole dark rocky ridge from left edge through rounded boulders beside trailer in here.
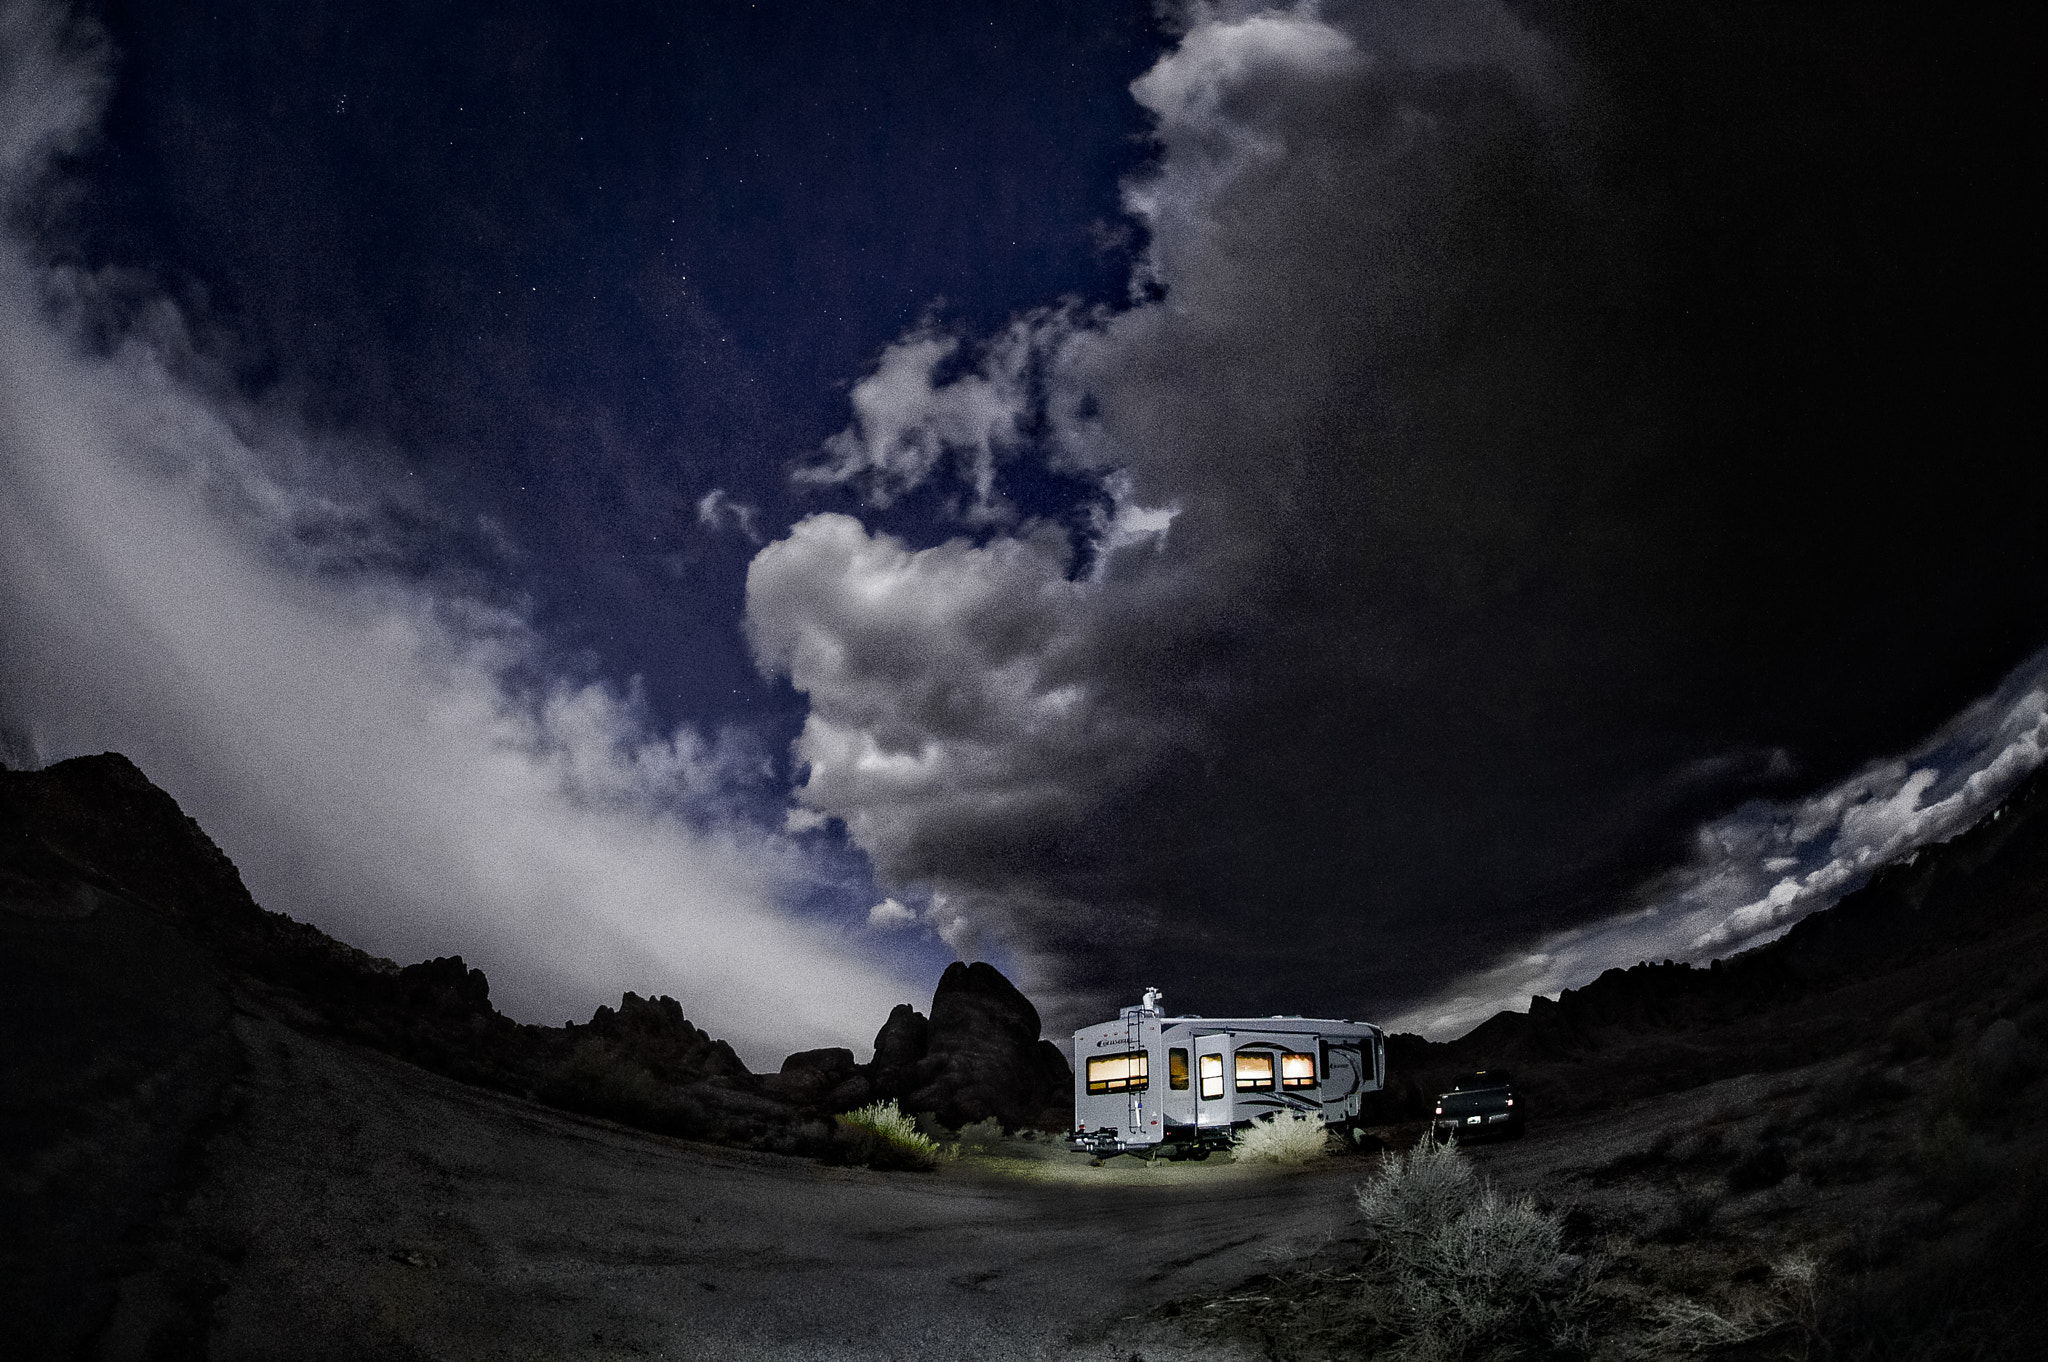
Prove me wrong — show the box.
[0,754,1071,1159]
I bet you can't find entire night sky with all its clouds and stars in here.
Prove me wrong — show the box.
[0,0,2048,1065]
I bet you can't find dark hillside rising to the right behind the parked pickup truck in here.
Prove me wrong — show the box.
[1389,757,2048,1116]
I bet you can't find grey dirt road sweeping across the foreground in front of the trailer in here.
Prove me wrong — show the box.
[100,1016,1366,1362]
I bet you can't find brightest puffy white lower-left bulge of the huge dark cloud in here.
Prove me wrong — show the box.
[748,514,1187,860]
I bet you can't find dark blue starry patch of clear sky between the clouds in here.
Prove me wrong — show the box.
[80,2,1165,739]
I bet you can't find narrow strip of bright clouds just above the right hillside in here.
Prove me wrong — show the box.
[1391,653,2048,1038]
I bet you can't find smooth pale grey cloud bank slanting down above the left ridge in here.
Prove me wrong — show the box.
[0,4,915,1065]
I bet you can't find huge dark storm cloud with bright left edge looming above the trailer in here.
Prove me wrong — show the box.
[748,0,2032,1036]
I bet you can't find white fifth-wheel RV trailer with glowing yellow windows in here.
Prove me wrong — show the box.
[1067,989,1386,1159]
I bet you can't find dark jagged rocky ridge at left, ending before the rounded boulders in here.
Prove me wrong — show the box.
[0,754,834,1155]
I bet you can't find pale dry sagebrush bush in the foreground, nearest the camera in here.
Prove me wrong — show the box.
[1358,1137,1581,1362]
